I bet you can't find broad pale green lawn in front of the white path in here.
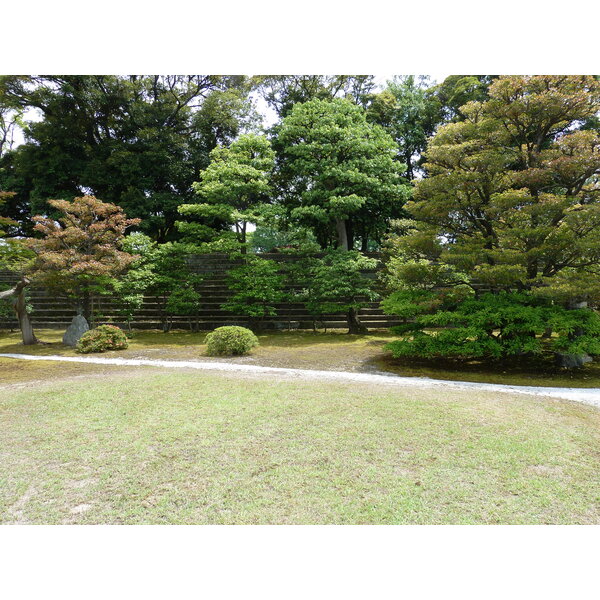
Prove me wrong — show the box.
[0,368,600,524]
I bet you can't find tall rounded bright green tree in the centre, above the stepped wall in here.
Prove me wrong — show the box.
[277,99,409,251]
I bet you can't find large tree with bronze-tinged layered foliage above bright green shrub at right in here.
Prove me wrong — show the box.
[382,76,600,366]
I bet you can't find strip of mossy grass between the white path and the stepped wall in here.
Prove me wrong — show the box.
[0,330,600,388]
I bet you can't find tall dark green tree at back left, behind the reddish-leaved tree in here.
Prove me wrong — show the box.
[0,75,252,241]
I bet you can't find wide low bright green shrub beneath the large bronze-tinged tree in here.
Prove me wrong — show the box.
[383,290,600,359]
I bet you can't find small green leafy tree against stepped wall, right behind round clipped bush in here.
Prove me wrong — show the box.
[221,256,284,320]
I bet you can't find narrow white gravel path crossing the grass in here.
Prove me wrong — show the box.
[0,354,600,407]
